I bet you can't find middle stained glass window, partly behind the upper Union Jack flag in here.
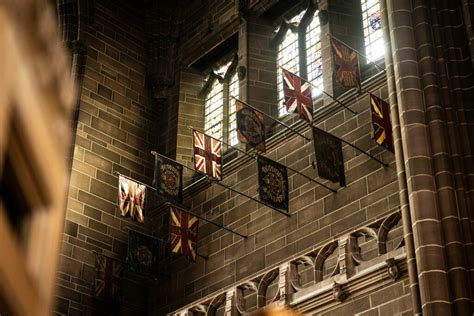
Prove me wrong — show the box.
[277,11,323,117]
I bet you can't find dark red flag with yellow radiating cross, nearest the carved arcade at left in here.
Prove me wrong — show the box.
[170,206,199,262]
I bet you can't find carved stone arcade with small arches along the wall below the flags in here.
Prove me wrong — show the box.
[170,211,406,316]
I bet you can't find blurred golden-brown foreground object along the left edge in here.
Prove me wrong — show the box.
[0,0,75,316]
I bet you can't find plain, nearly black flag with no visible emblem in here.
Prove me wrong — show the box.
[313,126,346,187]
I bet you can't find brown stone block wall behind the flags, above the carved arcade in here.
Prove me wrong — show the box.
[150,0,409,315]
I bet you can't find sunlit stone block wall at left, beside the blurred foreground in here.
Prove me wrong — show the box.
[54,1,157,315]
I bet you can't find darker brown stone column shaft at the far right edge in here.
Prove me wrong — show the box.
[413,0,472,315]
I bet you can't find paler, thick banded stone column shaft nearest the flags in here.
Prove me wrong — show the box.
[387,1,452,315]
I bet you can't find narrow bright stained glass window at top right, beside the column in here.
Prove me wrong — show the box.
[361,0,384,62]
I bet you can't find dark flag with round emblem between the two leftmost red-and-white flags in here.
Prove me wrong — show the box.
[154,155,183,204]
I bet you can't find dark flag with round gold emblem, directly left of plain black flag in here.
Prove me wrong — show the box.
[257,155,288,212]
